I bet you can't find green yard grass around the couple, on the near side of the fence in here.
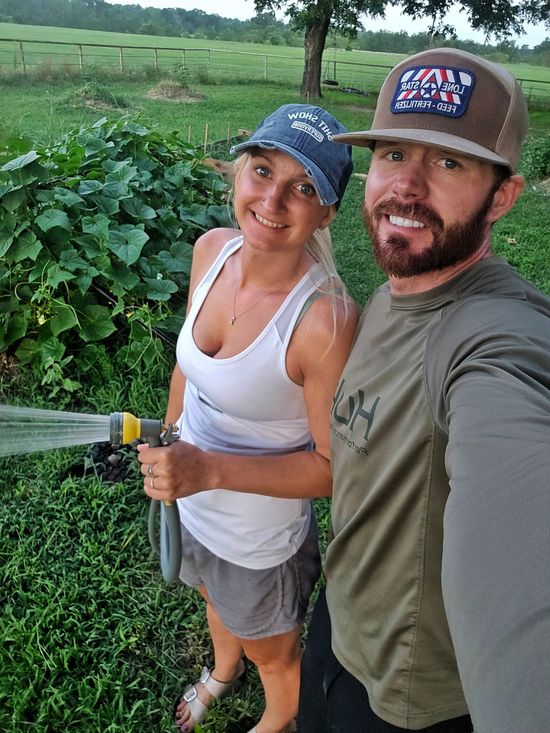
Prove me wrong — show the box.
[0,25,550,733]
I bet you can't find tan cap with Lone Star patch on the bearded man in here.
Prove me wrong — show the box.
[332,48,529,172]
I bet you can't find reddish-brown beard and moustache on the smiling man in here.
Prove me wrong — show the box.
[363,186,498,278]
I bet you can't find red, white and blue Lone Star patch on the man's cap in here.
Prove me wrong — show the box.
[390,66,475,117]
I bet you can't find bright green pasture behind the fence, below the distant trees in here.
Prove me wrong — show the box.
[0,23,550,98]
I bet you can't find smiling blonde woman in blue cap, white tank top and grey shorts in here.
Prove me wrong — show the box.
[139,104,357,733]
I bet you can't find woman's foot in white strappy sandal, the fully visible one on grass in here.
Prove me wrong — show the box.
[174,659,246,733]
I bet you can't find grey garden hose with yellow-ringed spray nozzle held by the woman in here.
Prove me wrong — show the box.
[110,412,181,583]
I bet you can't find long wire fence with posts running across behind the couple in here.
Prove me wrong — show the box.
[0,38,550,101]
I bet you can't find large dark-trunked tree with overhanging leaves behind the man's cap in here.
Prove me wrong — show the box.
[254,0,550,97]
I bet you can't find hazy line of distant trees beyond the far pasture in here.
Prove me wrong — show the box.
[0,0,550,66]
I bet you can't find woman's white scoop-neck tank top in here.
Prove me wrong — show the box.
[176,236,327,569]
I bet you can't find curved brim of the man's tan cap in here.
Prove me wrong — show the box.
[332,128,512,170]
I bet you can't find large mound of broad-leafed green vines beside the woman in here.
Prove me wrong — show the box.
[0,117,230,391]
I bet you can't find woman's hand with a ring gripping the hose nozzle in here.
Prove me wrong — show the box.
[137,440,210,501]
